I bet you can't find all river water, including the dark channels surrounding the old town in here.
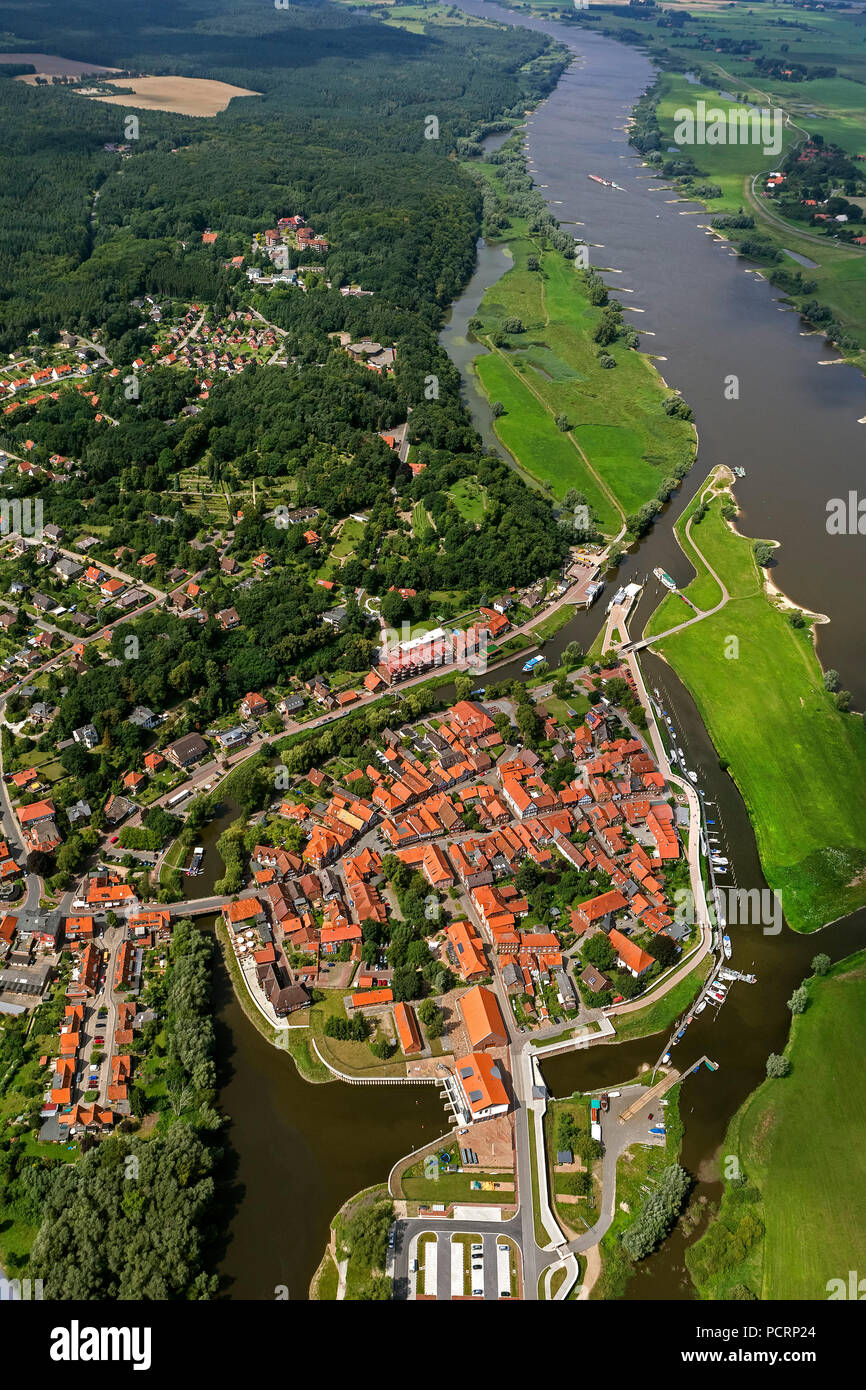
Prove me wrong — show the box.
[218,0,866,1298]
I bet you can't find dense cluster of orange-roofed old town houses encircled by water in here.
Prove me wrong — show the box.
[204,689,681,1056]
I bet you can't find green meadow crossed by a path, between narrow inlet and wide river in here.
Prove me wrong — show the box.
[471,164,694,535]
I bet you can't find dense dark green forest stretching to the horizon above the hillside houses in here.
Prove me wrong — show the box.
[0,0,562,350]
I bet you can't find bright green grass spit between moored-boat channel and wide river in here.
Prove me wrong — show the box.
[644,480,866,931]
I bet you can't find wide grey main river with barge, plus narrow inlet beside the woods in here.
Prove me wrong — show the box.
[442,0,866,709]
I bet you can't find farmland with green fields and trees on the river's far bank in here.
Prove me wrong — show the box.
[558,0,866,370]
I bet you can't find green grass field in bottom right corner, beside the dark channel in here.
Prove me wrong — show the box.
[688,952,866,1300]
